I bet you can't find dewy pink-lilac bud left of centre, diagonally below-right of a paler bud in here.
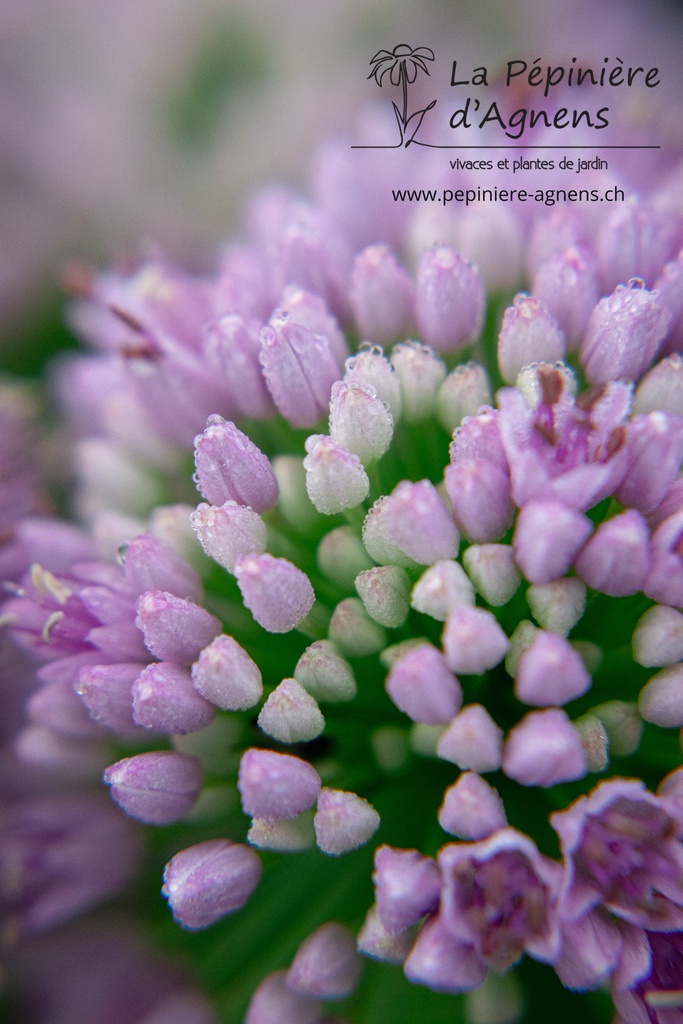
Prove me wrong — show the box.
[234,555,315,633]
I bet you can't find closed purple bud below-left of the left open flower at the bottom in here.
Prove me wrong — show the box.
[403,914,486,993]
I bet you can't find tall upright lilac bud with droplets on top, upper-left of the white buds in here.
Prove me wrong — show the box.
[259,314,340,423]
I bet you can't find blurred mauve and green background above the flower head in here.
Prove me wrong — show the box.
[0,0,682,374]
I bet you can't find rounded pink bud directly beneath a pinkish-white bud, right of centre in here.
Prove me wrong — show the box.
[441,605,508,676]
